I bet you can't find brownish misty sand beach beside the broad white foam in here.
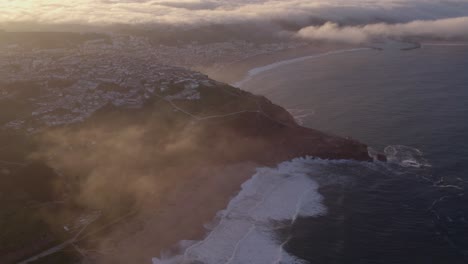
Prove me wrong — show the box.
[91,162,261,264]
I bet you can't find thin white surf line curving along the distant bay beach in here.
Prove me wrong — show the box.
[232,48,372,88]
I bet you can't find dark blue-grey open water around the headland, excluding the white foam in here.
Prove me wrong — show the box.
[242,46,468,263]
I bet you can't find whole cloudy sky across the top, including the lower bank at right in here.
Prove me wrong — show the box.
[0,0,468,43]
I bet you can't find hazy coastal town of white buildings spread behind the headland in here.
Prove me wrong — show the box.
[0,34,302,132]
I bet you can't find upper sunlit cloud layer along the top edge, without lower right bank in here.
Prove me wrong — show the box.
[0,0,468,27]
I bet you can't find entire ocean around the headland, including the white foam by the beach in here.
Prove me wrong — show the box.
[153,44,468,264]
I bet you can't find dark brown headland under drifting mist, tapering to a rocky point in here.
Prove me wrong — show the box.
[0,67,371,263]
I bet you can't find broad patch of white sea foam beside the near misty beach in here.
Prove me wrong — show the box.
[153,158,326,264]
